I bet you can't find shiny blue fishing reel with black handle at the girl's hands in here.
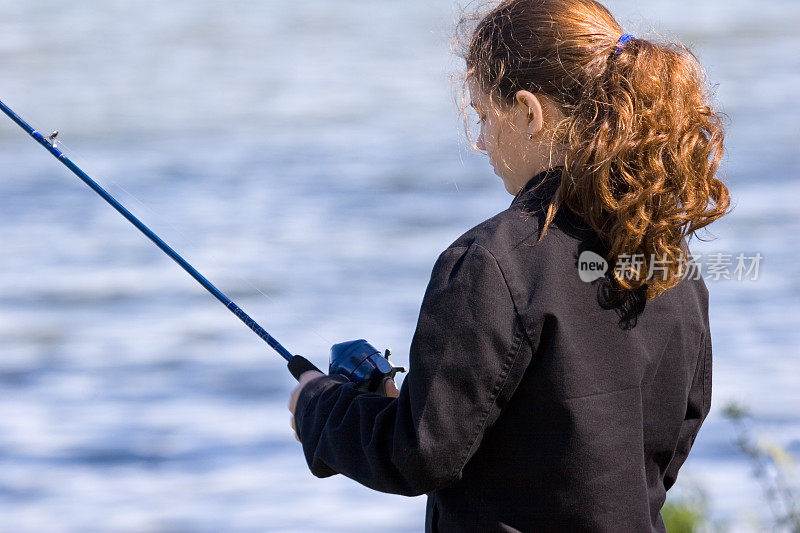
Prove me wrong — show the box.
[289,339,406,392]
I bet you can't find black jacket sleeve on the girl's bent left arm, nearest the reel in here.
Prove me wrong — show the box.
[295,243,530,496]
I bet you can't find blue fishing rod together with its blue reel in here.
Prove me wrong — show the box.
[0,101,405,391]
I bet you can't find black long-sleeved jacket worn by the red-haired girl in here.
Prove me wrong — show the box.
[295,168,711,532]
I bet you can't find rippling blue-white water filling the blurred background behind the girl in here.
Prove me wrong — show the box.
[0,0,800,532]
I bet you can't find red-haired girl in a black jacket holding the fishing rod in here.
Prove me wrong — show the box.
[290,0,729,532]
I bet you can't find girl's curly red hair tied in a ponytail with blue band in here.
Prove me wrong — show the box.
[456,0,730,299]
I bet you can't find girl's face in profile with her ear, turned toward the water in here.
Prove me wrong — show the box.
[468,77,563,195]
